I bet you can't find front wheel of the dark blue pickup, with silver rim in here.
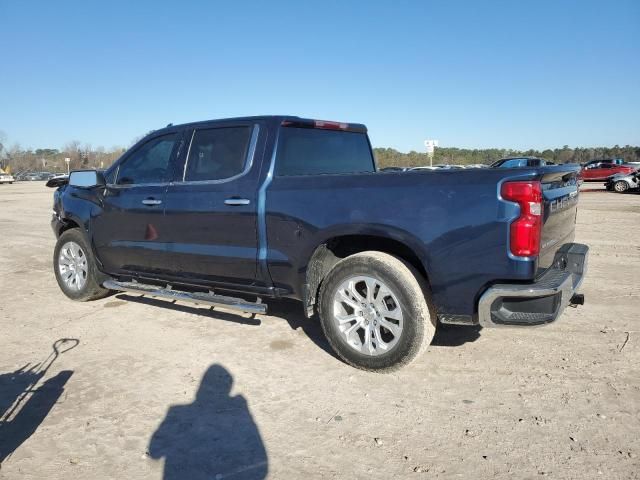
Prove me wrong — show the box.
[53,228,111,302]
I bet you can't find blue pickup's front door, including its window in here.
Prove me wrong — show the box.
[92,133,186,274]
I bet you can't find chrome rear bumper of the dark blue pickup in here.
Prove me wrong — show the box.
[478,243,589,327]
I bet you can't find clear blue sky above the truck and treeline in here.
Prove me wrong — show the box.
[0,0,640,151]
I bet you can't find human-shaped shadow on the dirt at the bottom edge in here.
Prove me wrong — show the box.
[149,365,268,480]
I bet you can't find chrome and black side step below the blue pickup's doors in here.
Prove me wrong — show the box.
[102,280,267,314]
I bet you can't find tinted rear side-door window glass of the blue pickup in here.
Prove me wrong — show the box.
[184,126,251,182]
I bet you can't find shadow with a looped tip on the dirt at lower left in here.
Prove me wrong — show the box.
[0,338,78,465]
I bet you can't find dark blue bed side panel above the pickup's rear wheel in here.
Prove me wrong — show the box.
[266,170,535,315]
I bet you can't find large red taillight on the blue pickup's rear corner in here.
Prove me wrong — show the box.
[500,182,542,257]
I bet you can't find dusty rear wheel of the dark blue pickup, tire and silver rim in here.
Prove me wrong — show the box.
[319,251,436,373]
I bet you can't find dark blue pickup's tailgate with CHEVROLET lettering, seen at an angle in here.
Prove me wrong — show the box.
[538,166,579,275]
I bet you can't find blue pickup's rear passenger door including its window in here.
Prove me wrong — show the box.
[165,122,266,286]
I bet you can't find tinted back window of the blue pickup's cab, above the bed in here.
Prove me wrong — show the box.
[276,127,374,176]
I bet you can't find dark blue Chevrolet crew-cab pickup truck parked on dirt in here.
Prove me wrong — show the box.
[50,116,588,371]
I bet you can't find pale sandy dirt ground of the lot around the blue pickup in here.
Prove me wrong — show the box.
[0,182,640,479]
